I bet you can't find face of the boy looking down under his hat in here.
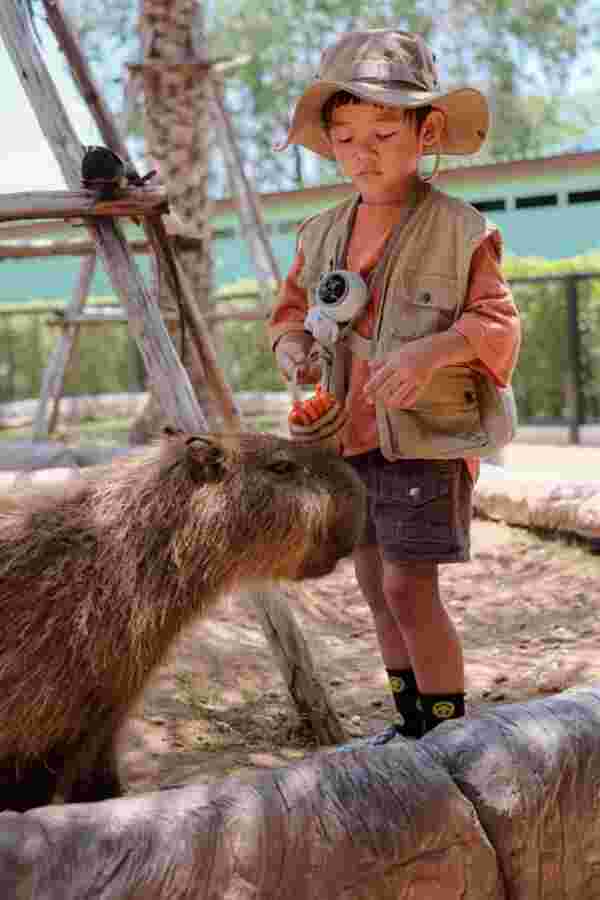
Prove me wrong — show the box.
[329,103,436,204]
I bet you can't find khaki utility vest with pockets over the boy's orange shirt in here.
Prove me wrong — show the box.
[300,184,504,460]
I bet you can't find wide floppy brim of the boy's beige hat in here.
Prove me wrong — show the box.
[281,81,490,159]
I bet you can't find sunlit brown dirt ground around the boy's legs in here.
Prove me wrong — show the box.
[122,506,600,792]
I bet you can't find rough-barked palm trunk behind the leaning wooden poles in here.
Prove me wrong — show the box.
[129,0,220,443]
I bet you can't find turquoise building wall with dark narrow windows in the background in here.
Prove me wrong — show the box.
[0,152,600,302]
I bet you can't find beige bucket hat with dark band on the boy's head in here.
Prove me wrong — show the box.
[278,28,490,159]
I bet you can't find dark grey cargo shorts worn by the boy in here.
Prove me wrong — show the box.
[345,450,473,563]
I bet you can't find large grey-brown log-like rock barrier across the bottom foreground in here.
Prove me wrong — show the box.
[0,685,600,900]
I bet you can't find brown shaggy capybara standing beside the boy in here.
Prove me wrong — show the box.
[0,431,364,811]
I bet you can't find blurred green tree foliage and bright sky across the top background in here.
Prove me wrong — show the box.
[65,0,598,190]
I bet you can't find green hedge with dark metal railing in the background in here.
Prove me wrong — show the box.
[0,272,600,444]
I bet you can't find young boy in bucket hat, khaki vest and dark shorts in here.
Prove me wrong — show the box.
[269,29,520,744]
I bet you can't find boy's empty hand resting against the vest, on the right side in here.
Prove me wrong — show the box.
[363,339,437,409]
